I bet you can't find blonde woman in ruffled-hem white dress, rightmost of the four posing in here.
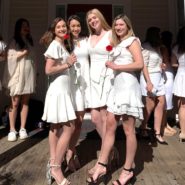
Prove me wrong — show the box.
[87,14,143,185]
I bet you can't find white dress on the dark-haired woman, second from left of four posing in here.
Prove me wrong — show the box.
[70,38,90,111]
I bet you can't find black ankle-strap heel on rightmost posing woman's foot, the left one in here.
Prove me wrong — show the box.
[86,162,107,184]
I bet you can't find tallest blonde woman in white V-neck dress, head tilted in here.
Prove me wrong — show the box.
[86,9,112,138]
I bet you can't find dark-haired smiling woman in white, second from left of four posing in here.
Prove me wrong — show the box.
[66,15,90,171]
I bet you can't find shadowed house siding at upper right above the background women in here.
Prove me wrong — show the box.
[131,0,178,40]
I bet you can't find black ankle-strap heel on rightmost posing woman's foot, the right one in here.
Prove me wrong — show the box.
[112,168,134,185]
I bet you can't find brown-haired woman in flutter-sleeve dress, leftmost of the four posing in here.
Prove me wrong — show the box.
[40,18,77,185]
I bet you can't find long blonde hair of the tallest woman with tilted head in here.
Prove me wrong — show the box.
[86,8,111,34]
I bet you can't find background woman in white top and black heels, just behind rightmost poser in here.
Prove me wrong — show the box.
[140,27,167,145]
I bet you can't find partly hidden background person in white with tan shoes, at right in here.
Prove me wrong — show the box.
[161,31,177,136]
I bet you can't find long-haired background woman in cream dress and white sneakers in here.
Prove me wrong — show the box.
[3,18,36,141]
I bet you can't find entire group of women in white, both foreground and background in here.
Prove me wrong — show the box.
[0,9,185,185]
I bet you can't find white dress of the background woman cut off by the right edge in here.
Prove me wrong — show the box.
[173,47,185,97]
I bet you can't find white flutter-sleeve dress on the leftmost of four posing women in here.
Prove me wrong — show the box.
[42,40,76,123]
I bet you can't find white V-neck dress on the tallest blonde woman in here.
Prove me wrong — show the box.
[88,31,113,108]
